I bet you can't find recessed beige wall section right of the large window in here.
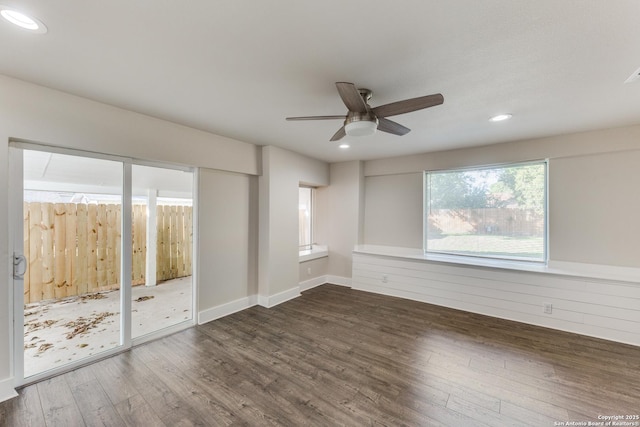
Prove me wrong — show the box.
[549,150,640,268]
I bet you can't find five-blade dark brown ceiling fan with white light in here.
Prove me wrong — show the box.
[287,82,444,141]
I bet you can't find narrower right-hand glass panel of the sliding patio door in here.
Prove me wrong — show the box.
[131,165,193,339]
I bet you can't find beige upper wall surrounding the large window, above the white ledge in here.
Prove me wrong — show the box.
[364,126,640,268]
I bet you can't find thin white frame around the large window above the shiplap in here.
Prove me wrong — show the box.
[422,159,549,266]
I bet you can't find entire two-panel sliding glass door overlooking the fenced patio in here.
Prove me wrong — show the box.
[10,143,193,384]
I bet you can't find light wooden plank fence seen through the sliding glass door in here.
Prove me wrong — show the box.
[23,202,193,304]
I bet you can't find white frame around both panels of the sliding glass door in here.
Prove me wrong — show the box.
[8,139,198,387]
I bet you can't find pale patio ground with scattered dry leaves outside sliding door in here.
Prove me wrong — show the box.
[24,277,193,378]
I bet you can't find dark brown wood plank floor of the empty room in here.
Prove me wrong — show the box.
[0,285,640,426]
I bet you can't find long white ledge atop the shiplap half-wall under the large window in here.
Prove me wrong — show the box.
[353,245,640,284]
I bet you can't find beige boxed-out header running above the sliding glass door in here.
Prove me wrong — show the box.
[0,75,260,175]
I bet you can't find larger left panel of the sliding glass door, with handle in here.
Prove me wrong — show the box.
[17,150,123,378]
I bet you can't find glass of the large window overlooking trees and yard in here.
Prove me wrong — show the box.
[425,161,547,262]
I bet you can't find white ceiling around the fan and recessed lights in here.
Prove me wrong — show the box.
[0,0,640,162]
